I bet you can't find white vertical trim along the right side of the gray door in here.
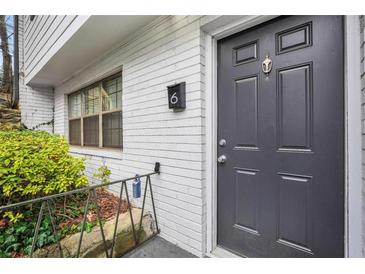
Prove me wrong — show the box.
[344,15,364,258]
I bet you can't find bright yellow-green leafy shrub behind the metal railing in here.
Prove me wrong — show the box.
[0,130,87,203]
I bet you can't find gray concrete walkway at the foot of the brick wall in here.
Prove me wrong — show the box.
[123,236,196,258]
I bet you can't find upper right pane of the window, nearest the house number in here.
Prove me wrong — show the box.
[102,76,122,111]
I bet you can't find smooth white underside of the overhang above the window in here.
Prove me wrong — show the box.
[26,15,158,87]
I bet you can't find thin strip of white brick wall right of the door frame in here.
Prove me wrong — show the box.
[360,15,365,257]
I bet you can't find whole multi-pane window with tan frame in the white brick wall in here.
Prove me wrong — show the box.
[68,73,123,148]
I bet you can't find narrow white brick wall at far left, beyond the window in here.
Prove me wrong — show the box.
[19,16,54,132]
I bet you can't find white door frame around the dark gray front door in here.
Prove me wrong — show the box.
[201,15,362,257]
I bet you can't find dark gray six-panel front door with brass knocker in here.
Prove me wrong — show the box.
[218,16,344,257]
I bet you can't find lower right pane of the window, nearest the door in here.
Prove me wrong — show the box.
[103,111,123,147]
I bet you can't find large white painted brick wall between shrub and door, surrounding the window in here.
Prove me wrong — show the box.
[55,16,206,256]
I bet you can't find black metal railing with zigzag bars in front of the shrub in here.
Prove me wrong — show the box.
[0,162,160,258]
